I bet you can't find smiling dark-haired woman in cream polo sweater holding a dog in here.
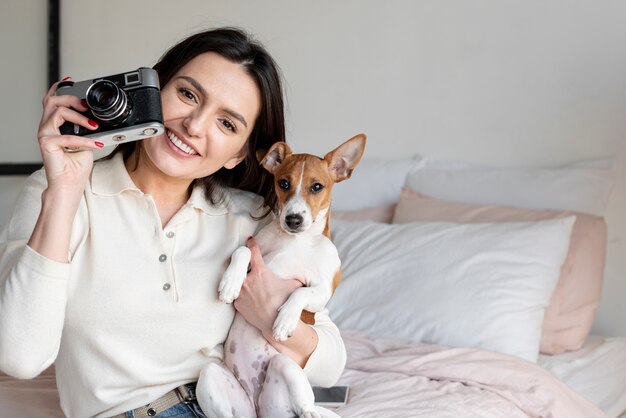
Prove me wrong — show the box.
[0,28,345,417]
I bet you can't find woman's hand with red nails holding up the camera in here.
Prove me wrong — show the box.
[37,77,103,195]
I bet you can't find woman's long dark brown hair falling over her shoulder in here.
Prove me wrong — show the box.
[107,27,285,216]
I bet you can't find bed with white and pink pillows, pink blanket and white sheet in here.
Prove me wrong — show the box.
[0,156,626,418]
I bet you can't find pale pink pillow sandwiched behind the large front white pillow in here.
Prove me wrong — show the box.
[393,189,607,354]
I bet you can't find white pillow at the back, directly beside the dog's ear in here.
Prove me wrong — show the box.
[332,158,420,211]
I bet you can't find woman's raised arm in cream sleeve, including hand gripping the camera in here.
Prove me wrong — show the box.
[0,76,99,378]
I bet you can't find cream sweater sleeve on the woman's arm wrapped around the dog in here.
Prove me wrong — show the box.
[304,310,347,387]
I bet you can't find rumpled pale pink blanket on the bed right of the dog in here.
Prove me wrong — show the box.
[335,332,606,418]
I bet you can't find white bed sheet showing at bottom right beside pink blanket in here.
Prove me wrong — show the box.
[538,336,626,418]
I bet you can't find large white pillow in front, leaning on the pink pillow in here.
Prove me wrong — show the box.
[328,216,575,362]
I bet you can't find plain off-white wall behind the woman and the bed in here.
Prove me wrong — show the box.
[0,0,626,336]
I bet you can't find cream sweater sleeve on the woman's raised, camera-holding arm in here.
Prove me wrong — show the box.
[0,172,70,379]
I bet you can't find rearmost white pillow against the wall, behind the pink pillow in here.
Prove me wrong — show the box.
[405,157,613,216]
